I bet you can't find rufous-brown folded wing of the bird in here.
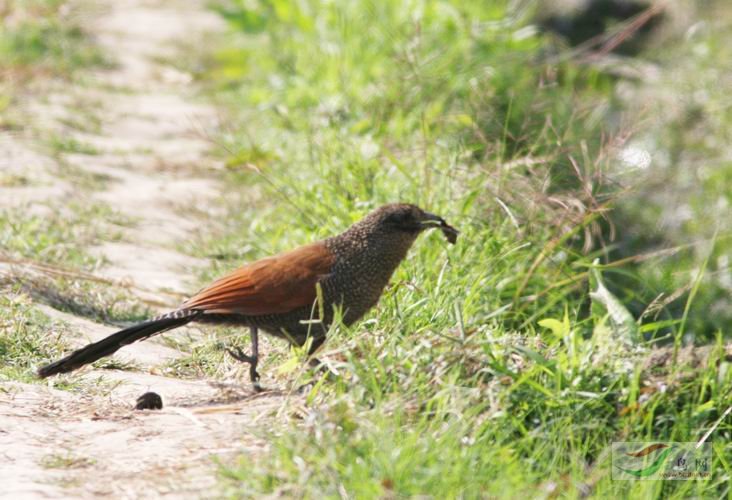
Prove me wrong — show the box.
[183,242,335,316]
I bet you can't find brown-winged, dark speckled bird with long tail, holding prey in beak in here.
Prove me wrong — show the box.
[37,203,458,390]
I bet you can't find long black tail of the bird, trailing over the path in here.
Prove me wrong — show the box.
[38,309,201,378]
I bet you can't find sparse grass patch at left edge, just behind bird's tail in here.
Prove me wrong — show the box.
[0,203,149,380]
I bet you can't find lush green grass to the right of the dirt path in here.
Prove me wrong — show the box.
[184,0,732,498]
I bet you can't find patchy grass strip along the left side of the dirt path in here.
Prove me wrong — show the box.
[0,0,150,392]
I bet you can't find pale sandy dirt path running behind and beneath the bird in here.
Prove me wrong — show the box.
[0,0,292,499]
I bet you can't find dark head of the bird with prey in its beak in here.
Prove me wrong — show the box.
[367,203,458,244]
